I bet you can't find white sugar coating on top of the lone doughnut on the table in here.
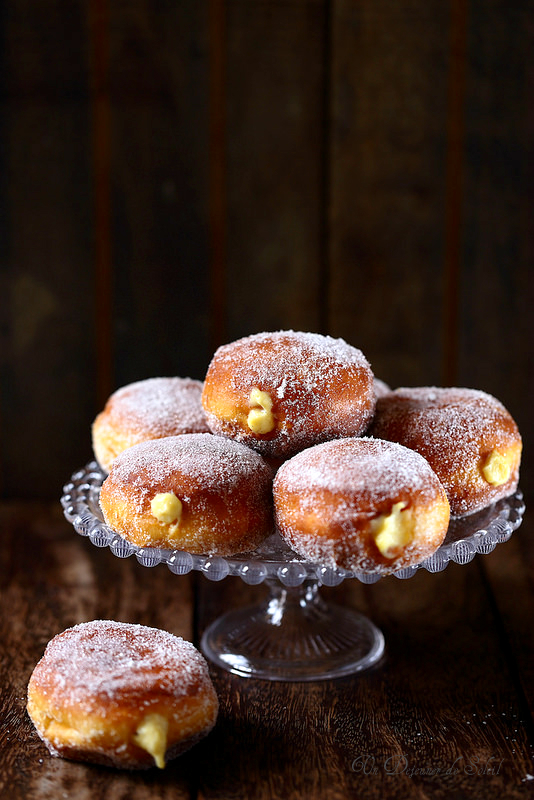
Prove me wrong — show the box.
[32,620,210,714]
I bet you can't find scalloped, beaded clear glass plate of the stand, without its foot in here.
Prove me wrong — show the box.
[61,461,525,587]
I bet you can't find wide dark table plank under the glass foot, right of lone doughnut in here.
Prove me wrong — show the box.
[192,528,534,800]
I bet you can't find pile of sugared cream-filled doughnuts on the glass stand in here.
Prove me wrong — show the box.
[93,331,521,573]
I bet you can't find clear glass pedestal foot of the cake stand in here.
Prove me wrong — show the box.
[200,581,384,681]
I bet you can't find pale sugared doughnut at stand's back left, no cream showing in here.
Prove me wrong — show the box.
[92,378,209,472]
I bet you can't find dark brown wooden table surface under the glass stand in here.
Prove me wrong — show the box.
[0,502,534,800]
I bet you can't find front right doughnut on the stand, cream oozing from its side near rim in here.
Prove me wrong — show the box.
[274,437,449,573]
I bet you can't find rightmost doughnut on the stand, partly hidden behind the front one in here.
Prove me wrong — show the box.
[371,386,522,516]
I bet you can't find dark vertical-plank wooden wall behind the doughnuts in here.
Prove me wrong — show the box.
[0,0,534,506]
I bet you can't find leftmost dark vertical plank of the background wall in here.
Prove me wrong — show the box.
[0,0,94,497]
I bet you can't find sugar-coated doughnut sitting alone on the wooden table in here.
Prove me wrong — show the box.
[27,620,218,769]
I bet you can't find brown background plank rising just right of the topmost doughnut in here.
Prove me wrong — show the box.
[328,0,450,386]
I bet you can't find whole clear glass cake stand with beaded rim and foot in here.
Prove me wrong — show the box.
[61,462,525,681]
